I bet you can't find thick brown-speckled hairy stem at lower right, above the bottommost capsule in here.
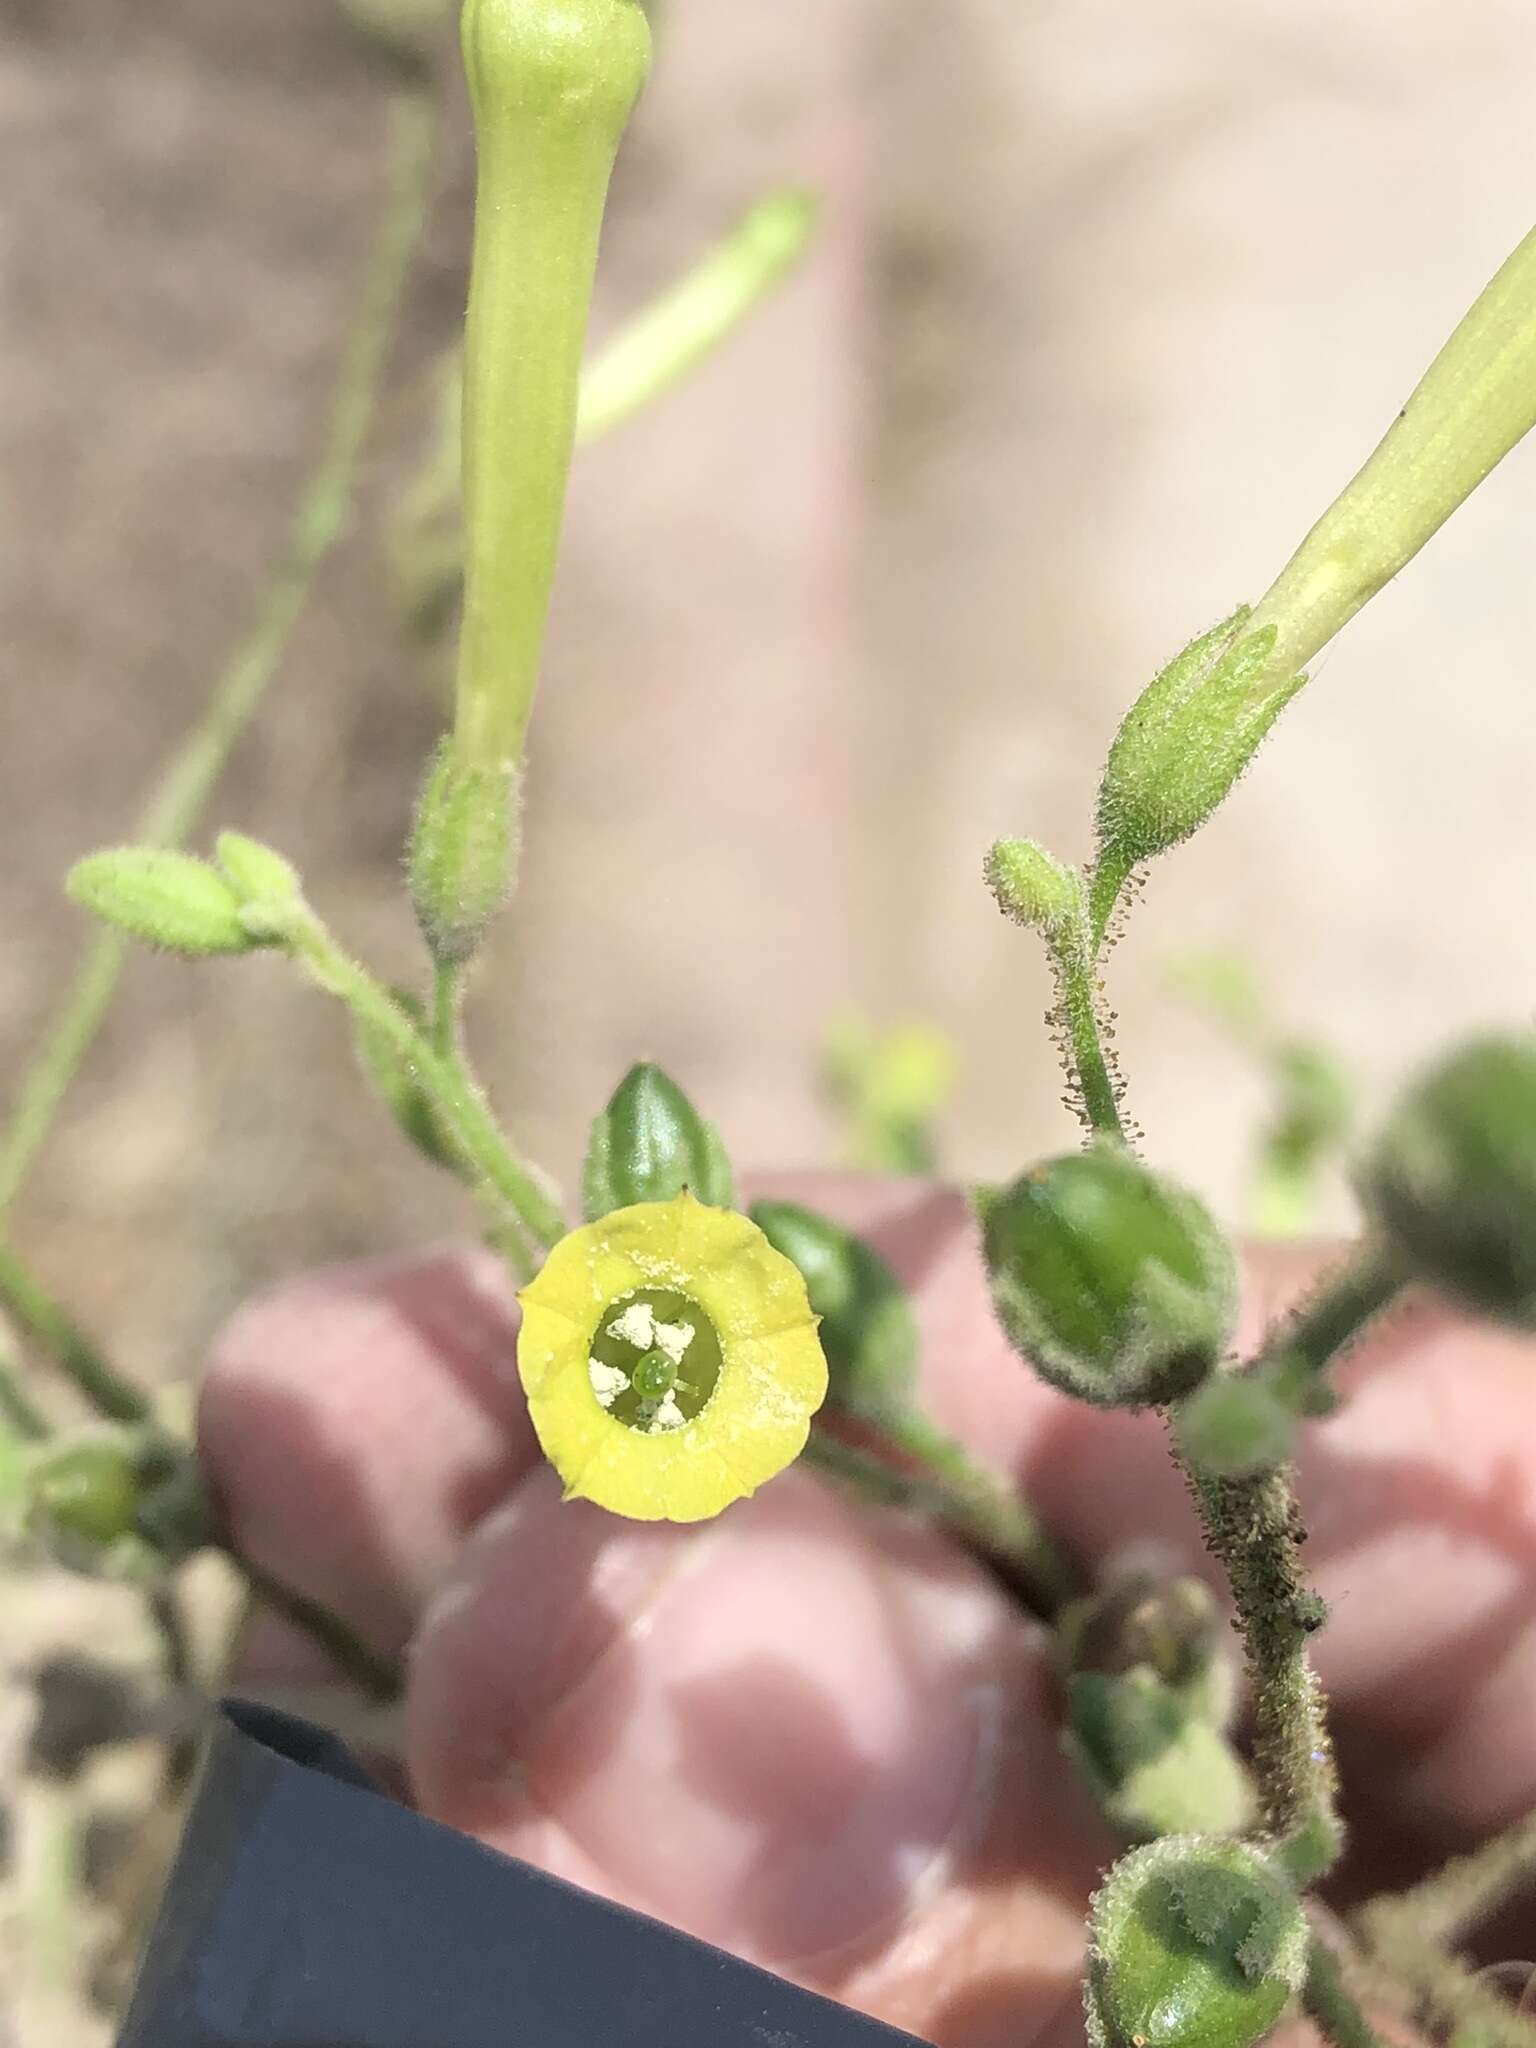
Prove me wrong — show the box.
[1174,1450,1343,1886]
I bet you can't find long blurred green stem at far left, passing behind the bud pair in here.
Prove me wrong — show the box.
[0,90,436,1231]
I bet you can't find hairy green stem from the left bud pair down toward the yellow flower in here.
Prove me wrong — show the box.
[287,913,565,1251]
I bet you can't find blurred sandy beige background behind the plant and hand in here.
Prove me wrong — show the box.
[0,0,1536,2039]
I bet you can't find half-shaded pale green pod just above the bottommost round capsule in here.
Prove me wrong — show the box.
[1063,1665,1257,1841]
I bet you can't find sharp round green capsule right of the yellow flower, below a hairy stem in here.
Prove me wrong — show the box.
[983,1141,1237,1407]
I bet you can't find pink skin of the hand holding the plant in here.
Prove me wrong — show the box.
[201,1176,1536,2048]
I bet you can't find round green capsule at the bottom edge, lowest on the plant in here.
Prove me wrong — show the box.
[1083,1835,1311,2048]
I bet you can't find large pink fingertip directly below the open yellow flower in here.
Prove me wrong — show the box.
[408,1473,1048,1970]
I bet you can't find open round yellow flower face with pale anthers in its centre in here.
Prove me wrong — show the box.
[518,1194,827,1522]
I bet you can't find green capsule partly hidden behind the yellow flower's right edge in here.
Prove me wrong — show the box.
[752,1202,918,1421]
